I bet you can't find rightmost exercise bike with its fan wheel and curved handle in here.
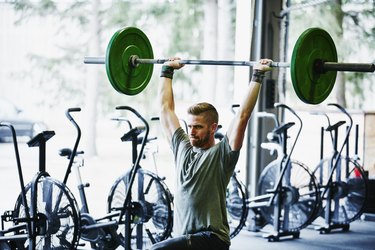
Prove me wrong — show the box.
[314,103,368,234]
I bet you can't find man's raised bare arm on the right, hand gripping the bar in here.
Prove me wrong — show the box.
[227,59,271,151]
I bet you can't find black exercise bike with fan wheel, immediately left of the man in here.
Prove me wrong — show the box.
[108,106,173,249]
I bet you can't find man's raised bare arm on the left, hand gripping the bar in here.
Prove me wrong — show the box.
[159,58,183,144]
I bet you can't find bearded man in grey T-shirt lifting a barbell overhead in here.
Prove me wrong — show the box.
[151,58,271,250]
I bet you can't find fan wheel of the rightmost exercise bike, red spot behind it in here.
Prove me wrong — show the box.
[314,157,368,224]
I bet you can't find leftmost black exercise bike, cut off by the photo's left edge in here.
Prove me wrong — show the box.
[0,123,80,250]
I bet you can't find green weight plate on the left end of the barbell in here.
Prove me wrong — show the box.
[105,27,154,95]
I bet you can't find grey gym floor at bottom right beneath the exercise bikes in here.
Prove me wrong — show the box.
[230,215,375,250]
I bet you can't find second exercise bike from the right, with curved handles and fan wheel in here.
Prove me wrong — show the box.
[225,104,320,241]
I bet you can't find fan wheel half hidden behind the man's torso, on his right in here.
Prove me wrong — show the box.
[226,173,249,239]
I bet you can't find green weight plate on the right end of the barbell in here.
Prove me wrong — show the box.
[290,28,337,104]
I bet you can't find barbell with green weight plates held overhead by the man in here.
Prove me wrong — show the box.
[84,27,375,104]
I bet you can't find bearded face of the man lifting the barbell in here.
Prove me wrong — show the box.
[188,115,215,149]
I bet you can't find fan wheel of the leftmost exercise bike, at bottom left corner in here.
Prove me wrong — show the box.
[14,177,80,250]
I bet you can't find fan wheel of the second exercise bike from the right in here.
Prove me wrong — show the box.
[258,161,320,232]
